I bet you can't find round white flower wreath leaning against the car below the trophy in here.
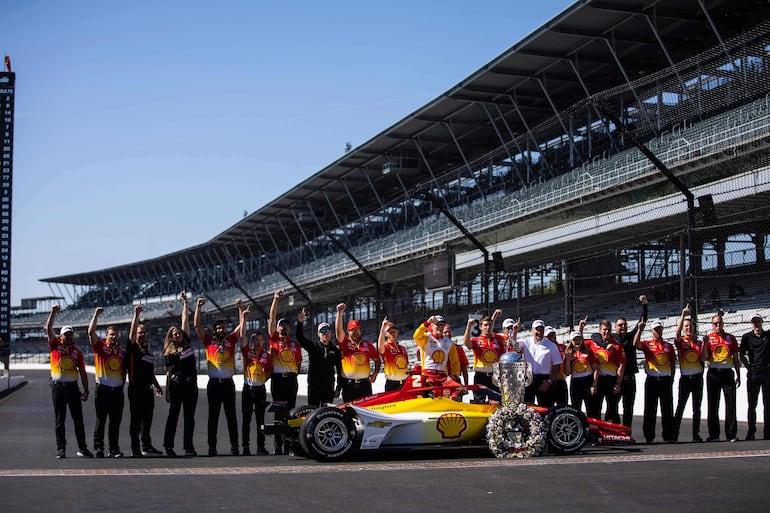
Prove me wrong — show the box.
[487,403,545,458]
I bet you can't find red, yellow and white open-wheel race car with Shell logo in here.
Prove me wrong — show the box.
[268,375,634,461]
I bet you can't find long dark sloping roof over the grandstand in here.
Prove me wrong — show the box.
[42,0,769,285]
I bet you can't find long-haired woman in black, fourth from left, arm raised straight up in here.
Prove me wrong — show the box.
[163,292,198,457]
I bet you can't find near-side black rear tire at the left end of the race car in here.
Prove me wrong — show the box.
[299,406,361,461]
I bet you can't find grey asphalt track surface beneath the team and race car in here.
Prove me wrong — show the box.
[0,371,770,513]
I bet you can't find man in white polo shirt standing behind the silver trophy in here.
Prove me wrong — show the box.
[513,319,562,406]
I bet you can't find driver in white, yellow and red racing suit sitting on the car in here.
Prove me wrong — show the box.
[413,315,460,387]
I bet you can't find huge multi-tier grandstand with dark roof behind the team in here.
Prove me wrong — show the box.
[12,0,770,356]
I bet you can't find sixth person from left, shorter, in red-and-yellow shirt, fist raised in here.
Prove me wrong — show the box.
[241,316,273,456]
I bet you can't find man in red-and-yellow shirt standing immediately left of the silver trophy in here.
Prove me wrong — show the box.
[463,316,504,403]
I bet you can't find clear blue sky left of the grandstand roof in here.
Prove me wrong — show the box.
[0,0,572,305]
